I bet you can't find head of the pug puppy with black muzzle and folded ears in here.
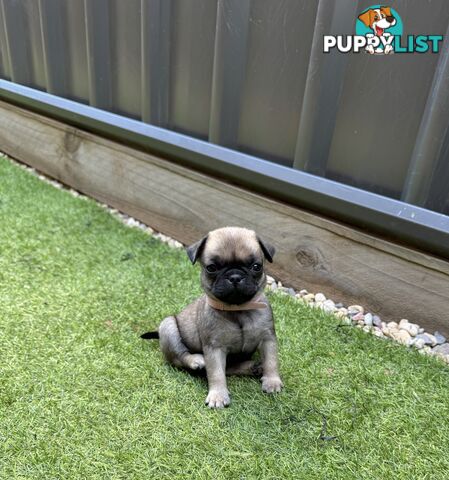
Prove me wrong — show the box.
[187,227,274,305]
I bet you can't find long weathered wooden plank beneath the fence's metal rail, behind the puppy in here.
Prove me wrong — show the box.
[0,102,449,334]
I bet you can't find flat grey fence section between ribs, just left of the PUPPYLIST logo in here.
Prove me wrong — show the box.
[236,0,317,165]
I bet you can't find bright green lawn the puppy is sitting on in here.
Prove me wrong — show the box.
[0,158,449,480]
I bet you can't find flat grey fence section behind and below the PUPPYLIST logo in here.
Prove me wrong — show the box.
[326,0,449,198]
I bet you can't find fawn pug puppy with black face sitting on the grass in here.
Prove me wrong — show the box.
[142,227,283,408]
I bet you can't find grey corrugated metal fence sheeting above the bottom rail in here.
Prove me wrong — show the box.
[0,0,449,244]
